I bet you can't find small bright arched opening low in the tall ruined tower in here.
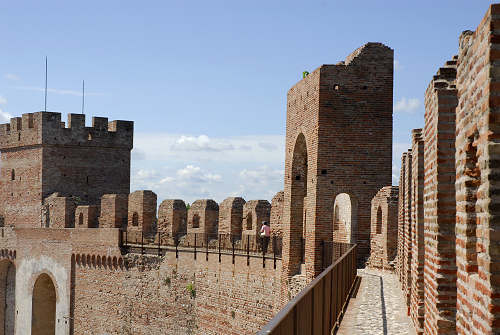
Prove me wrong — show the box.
[333,193,358,243]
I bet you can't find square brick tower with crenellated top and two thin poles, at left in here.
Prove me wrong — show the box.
[0,112,134,227]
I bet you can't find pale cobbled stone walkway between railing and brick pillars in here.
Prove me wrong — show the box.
[337,269,415,335]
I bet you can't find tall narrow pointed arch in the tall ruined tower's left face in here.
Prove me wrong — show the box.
[289,134,308,273]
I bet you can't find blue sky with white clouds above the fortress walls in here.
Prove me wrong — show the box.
[0,0,492,202]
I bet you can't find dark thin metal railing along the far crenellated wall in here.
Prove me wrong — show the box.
[120,231,283,268]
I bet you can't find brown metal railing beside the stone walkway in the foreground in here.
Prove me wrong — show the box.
[258,243,357,335]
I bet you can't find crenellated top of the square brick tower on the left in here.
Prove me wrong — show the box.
[0,112,134,150]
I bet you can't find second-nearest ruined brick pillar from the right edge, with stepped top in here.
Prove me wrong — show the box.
[424,57,458,334]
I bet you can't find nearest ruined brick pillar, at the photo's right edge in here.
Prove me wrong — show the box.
[455,4,500,334]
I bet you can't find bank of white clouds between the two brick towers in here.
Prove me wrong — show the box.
[131,133,285,202]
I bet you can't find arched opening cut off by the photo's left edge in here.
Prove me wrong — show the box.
[0,260,16,335]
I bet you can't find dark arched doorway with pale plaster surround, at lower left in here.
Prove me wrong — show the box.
[31,273,56,335]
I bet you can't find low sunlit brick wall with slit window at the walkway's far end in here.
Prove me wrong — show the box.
[368,186,399,270]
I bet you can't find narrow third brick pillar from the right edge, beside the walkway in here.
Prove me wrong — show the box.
[410,129,425,334]
